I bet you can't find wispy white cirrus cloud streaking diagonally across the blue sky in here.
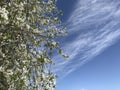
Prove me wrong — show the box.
[54,0,120,75]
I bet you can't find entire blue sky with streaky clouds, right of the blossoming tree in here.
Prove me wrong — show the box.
[54,0,120,90]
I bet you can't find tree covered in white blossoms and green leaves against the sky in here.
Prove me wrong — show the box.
[0,0,66,90]
